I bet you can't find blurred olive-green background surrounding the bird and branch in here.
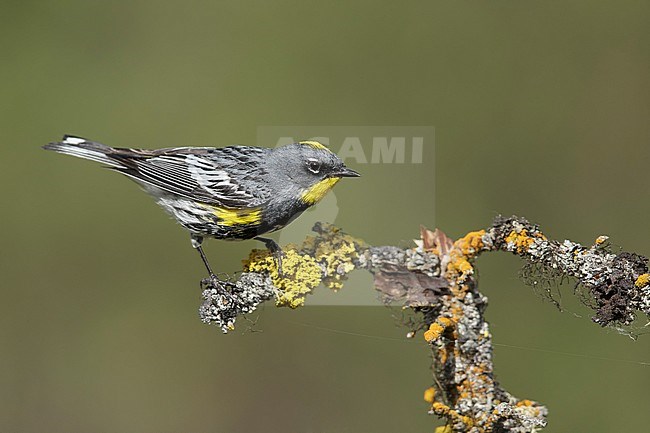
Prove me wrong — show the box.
[0,0,650,433]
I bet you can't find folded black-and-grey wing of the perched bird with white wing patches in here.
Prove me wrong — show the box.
[111,146,270,208]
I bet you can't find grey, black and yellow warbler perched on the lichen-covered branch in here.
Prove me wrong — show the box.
[43,135,359,285]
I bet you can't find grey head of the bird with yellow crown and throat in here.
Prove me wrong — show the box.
[269,141,360,206]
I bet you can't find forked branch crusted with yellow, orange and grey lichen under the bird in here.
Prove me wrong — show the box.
[200,217,650,433]
